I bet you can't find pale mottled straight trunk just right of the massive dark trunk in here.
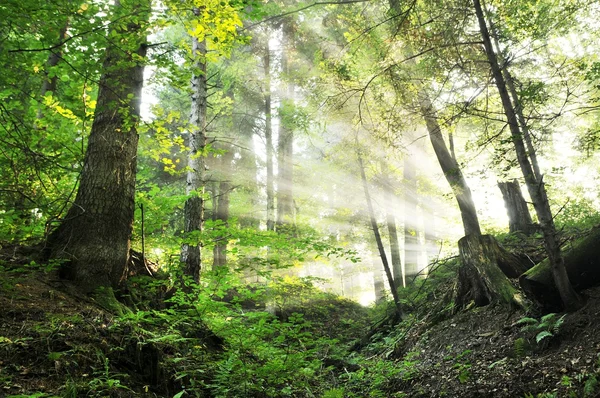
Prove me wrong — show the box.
[181,16,207,283]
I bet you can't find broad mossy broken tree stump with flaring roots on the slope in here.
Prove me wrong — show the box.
[458,235,526,307]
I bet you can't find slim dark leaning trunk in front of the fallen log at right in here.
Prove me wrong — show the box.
[473,0,582,311]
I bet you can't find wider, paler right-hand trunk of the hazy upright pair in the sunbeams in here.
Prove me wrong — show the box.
[277,19,295,229]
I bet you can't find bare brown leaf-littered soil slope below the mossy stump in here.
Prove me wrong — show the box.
[392,287,600,398]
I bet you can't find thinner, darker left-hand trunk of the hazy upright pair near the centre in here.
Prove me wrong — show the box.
[263,36,275,231]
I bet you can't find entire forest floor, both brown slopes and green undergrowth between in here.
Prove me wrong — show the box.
[0,246,600,398]
